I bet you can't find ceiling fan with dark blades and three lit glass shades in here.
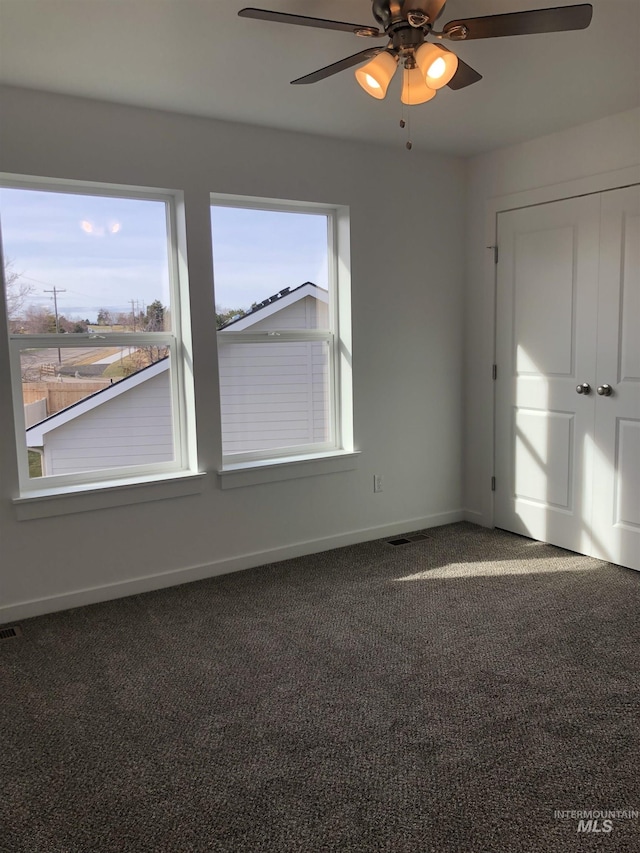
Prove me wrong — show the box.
[238,0,593,104]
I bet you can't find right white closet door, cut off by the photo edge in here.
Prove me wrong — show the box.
[591,186,640,570]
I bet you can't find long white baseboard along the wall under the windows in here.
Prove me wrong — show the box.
[0,509,464,625]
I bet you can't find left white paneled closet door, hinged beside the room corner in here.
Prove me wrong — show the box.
[495,191,600,553]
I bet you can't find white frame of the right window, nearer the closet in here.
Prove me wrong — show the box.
[211,193,354,470]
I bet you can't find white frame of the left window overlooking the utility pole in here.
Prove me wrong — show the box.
[0,180,197,500]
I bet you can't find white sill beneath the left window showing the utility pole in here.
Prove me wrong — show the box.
[13,471,205,521]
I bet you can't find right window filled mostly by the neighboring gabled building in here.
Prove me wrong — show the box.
[211,197,350,467]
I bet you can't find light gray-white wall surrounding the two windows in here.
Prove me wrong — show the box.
[0,88,465,622]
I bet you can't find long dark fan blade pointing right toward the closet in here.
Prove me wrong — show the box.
[443,3,593,41]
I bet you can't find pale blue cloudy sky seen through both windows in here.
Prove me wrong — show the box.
[0,188,328,322]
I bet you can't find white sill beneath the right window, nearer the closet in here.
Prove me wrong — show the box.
[218,450,360,489]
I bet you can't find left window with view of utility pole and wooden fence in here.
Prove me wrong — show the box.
[0,182,192,496]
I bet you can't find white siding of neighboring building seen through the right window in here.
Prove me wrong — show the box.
[219,296,331,454]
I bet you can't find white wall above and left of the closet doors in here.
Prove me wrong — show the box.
[463,109,640,525]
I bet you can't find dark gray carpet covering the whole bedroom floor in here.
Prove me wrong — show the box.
[0,523,640,853]
